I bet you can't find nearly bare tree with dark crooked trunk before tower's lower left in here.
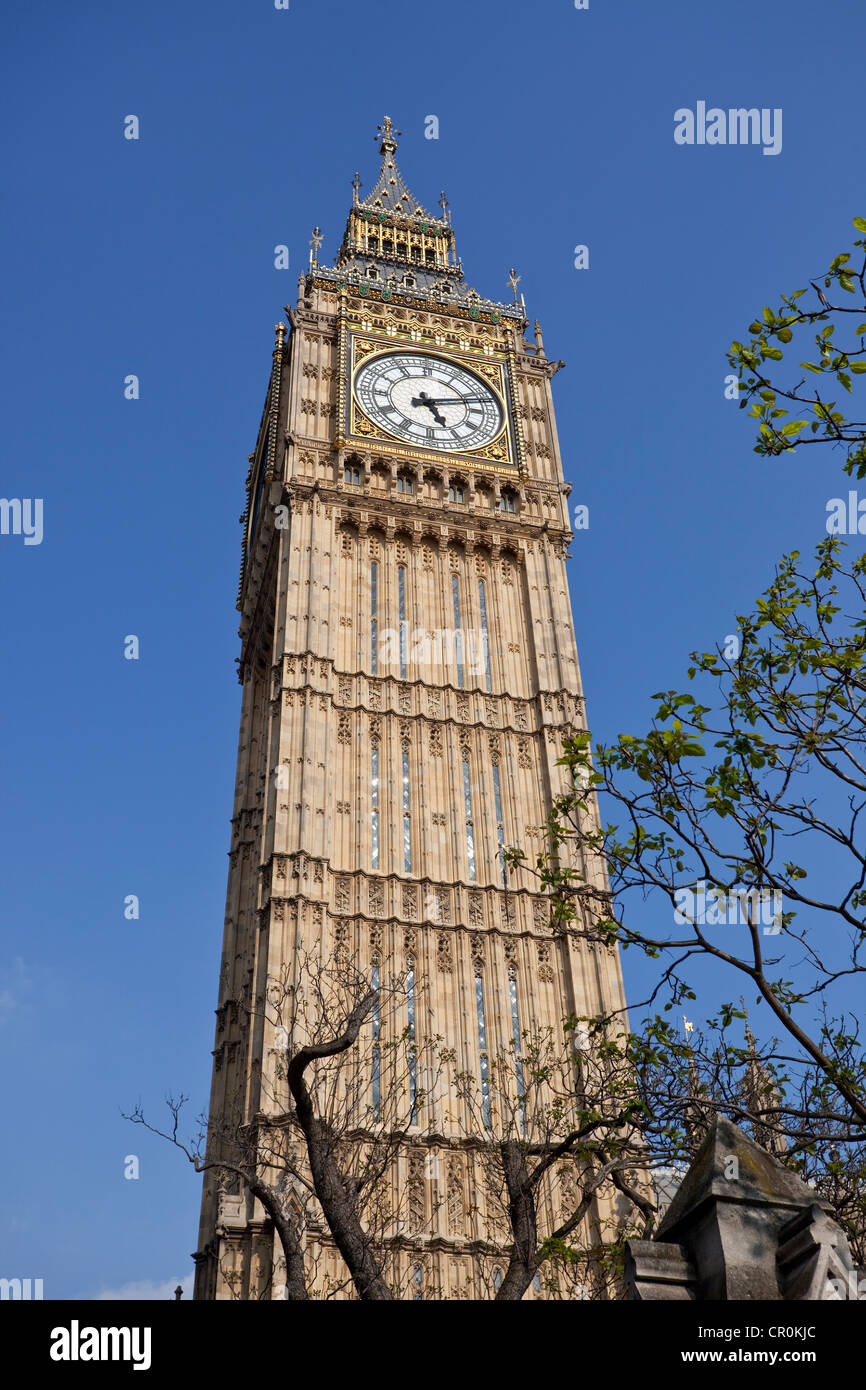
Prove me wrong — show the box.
[126,952,436,1301]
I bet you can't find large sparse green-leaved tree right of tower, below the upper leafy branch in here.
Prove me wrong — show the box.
[510,538,866,1126]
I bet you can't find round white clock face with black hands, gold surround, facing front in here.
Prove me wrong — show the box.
[354,352,503,452]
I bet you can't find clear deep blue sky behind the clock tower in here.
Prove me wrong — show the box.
[0,0,866,1298]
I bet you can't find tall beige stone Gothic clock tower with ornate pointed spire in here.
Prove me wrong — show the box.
[196,118,623,1298]
